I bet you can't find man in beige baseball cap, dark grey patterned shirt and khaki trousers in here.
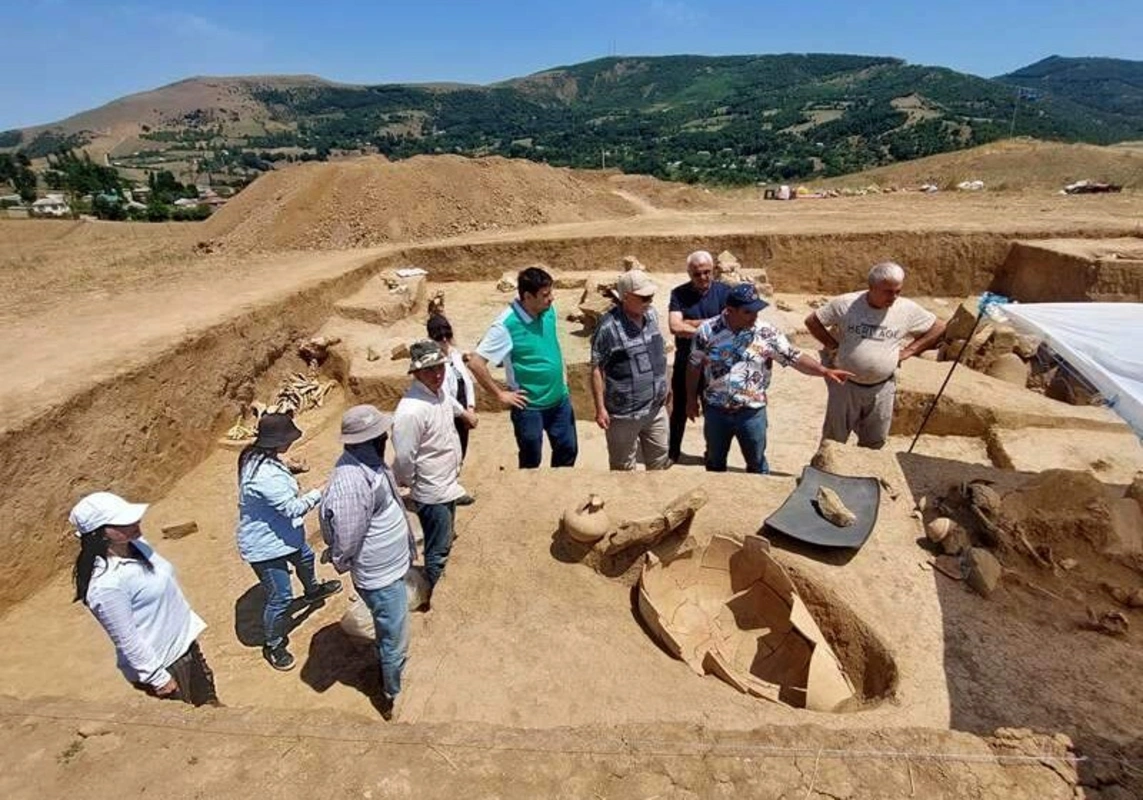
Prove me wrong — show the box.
[591,270,671,470]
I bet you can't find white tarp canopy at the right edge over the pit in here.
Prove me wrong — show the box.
[997,303,1143,439]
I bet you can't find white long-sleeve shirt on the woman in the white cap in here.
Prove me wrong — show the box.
[87,538,207,688]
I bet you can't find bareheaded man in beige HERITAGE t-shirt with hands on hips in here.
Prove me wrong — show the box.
[806,262,944,449]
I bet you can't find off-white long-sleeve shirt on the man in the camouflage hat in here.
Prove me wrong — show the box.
[393,378,464,504]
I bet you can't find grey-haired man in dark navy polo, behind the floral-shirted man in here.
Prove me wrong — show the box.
[666,250,730,462]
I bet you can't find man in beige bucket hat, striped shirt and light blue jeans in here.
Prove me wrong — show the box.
[319,406,416,719]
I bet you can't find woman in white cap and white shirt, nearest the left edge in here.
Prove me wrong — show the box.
[69,491,218,705]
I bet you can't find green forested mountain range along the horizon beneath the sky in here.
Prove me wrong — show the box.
[0,54,1143,183]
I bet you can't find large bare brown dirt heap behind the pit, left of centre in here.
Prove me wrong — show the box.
[202,155,637,250]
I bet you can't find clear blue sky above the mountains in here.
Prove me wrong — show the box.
[0,0,1143,130]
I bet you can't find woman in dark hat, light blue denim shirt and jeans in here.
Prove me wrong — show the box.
[237,414,342,671]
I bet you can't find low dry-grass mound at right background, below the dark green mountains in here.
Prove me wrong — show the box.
[826,138,1143,191]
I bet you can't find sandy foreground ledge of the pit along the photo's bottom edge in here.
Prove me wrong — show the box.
[0,701,1078,800]
